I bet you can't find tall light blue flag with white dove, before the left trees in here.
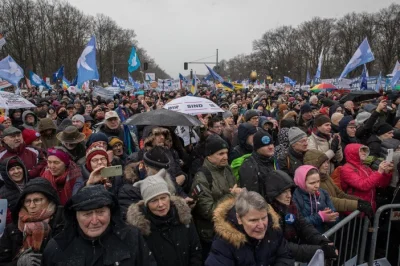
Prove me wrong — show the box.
[76,36,99,87]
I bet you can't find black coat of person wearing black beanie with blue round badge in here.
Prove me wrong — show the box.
[239,152,275,197]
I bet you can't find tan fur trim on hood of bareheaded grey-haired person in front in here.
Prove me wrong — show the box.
[213,197,281,248]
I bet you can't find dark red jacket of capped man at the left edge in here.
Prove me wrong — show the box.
[0,143,47,178]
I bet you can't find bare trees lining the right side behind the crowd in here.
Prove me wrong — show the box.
[218,4,400,83]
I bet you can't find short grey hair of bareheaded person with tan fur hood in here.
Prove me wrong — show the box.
[235,188,268,217]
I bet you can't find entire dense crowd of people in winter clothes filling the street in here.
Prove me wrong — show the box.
[0,85,400,266]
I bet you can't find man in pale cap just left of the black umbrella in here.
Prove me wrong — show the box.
[97,111,138,155]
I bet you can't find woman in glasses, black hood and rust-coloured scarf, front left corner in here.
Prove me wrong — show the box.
[0,177,63,266]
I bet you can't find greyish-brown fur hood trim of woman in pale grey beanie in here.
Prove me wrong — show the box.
[126,196,192,236]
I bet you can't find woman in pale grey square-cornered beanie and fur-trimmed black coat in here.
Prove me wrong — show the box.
[127,169,203,266]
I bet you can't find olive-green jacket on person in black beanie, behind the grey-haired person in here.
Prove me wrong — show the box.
[191,159,236,242]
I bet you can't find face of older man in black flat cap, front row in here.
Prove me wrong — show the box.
[76,207,111,238]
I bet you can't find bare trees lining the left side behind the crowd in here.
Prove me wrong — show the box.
[0,0,169,83]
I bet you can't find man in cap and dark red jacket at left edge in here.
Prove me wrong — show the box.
[0,127,46,178]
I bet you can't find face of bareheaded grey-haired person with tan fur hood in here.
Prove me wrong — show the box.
[236,209,268,240]
